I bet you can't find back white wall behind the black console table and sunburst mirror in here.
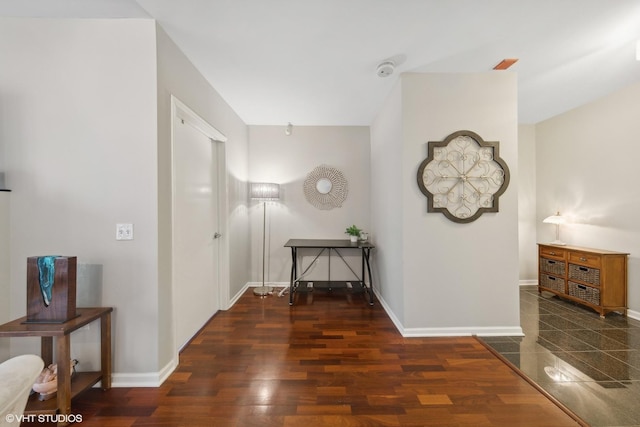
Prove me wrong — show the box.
[249,126,375,283]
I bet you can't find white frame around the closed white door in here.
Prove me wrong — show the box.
[171,95,230,356]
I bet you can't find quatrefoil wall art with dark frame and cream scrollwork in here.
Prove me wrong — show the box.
[418,130,509,223]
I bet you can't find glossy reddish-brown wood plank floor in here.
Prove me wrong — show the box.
[23,291,578,427]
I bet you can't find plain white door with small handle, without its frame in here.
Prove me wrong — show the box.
[173,116,220,350]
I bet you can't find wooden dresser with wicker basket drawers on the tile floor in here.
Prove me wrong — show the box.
[538,243,629,317]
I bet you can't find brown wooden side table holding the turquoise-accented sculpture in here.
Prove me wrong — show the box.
[0,307,113,424]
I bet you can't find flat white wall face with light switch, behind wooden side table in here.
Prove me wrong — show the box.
[0,19,158,372]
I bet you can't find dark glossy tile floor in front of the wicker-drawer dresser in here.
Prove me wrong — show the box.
[482,286,640,427]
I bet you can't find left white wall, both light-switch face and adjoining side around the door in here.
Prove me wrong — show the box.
[0,19,250,385]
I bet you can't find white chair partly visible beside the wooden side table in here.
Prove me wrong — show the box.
[0,354,44,427]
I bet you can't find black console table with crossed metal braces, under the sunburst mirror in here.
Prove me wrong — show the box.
[284,239,375,305]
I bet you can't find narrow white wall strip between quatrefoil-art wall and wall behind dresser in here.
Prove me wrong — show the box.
[517,125,538,284]
